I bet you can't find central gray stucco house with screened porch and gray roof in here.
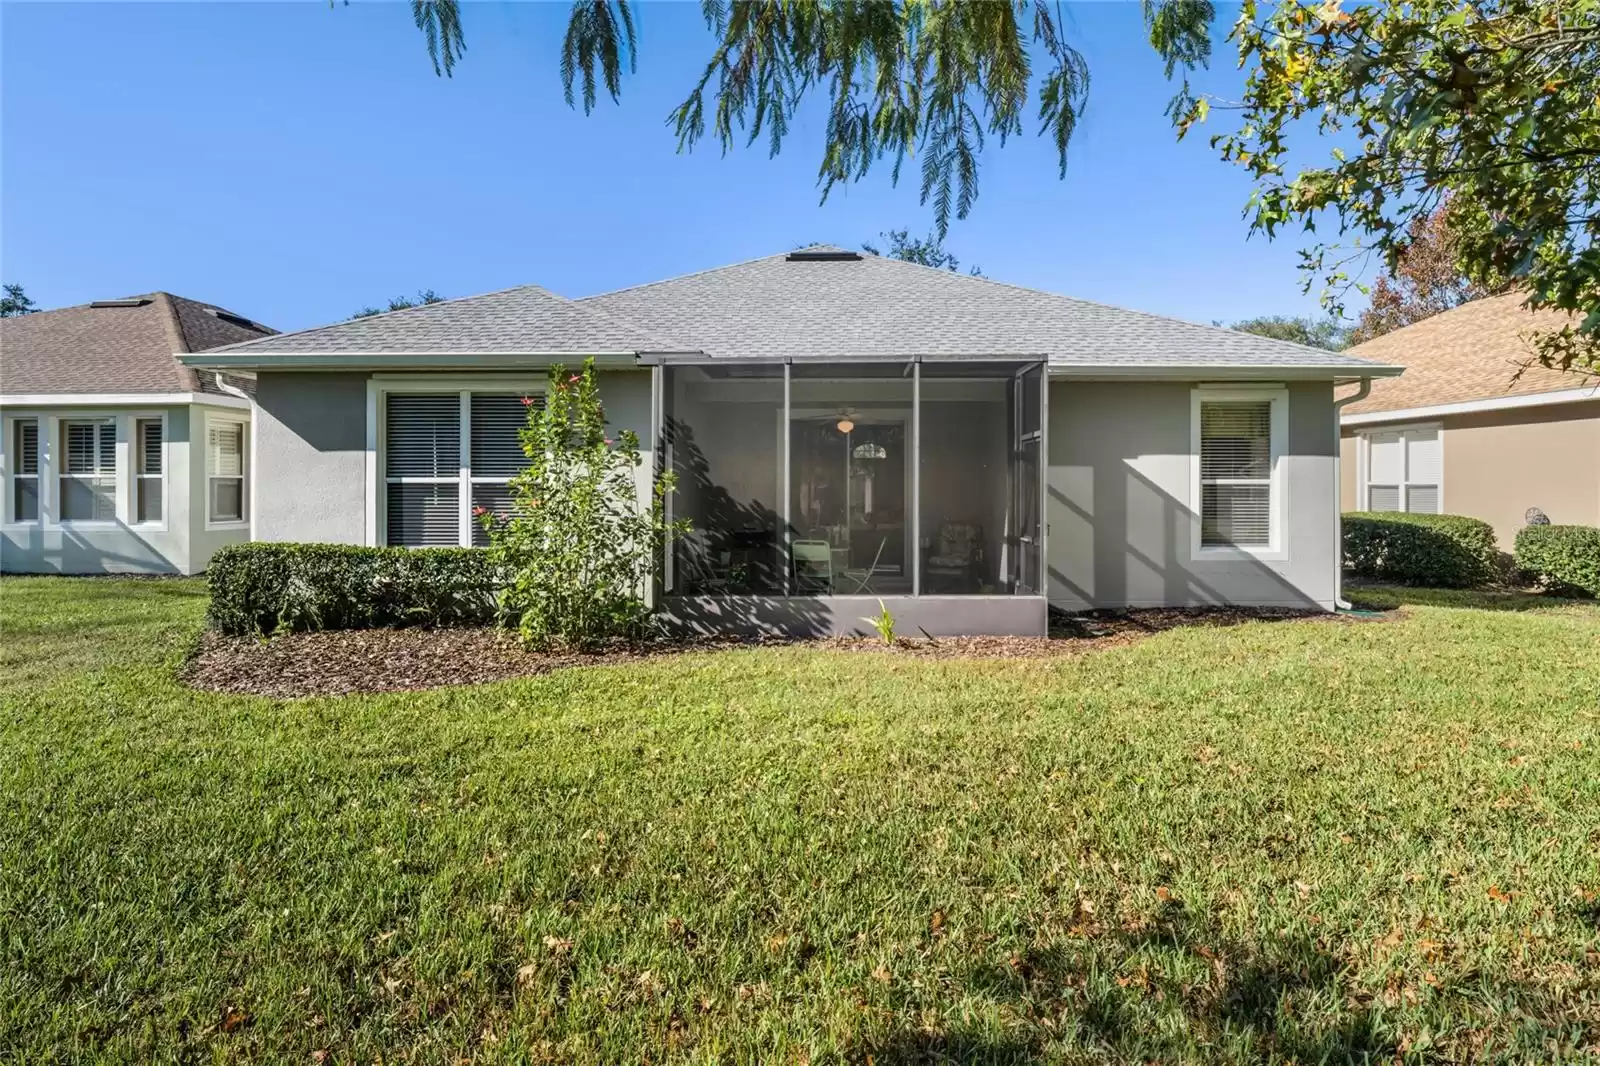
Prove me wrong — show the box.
[182,248,1400,634]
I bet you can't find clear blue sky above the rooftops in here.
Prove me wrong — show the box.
[0,2,1363,330]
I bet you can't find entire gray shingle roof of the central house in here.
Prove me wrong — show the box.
[187,246,1398,376]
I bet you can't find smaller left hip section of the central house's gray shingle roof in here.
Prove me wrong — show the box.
[201,285,675,355]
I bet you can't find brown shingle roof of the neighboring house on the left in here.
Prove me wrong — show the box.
[0,293,274,395]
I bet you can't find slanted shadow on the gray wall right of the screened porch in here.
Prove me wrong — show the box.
[1046,463,1333,608]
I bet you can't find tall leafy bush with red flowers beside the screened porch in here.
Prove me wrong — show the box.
[474,360,688,648]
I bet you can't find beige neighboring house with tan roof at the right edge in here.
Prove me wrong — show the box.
[1339,293,1600,551]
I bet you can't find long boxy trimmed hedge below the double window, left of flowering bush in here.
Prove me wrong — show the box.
[206,544,499,635]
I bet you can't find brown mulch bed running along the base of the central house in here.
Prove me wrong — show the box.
[182,608,1338,698]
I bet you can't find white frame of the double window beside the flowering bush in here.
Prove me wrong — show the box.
[366,375,549,547]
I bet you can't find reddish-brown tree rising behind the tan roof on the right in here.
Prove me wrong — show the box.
[1350,202,1506,344]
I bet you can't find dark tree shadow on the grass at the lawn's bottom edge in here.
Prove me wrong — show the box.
[851,900,1398,1066]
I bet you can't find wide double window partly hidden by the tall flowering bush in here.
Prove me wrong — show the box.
[381,391,544,547]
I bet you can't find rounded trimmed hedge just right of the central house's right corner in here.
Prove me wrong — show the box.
[1344,511,1501,589]
